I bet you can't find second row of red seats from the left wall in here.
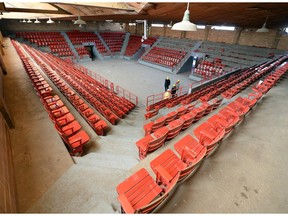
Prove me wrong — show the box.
[24,42,108,135]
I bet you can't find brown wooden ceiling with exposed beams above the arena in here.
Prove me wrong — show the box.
[0,1,288,28]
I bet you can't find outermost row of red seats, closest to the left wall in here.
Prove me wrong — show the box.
[12,41,90,156]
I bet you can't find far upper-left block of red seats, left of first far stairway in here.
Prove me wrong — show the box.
[16,32,74,57]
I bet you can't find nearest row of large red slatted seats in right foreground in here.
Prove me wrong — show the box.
[116,57,288,213]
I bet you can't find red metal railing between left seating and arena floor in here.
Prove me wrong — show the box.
[75,64,138,106]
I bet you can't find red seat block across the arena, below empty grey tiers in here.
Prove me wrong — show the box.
[142,46,187,68]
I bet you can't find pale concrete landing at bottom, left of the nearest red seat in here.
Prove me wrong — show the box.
[26,164,126,214]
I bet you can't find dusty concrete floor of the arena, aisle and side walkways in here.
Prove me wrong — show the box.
[4,40,288,213]
